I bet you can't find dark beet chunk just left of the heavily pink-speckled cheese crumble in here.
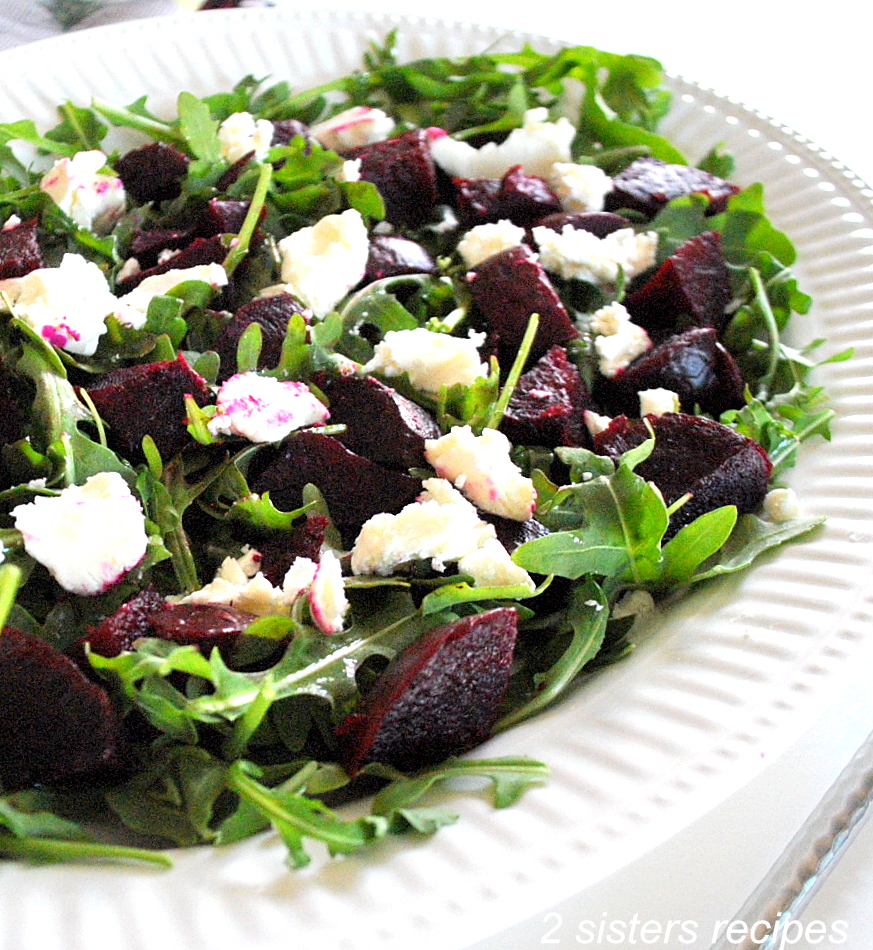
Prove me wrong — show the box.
[88,353,213,461]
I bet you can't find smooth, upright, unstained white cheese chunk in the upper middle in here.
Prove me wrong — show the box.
[278,208,370,317]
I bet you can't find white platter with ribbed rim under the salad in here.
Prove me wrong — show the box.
[0,9,873,950]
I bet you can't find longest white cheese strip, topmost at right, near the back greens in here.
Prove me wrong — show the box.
[431,108,576,178]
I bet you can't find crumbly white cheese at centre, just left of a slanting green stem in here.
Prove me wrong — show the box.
[363,327,488,394]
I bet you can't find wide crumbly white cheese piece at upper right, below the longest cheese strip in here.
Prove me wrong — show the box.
[532,224,658,287]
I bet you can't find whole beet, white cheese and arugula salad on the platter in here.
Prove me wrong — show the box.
[0,35,846,866]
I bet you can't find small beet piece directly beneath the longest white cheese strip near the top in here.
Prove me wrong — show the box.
[455,165,561,227]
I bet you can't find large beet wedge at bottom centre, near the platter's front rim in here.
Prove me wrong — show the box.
[338,607,517,774]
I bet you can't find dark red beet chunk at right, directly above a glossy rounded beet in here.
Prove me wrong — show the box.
[625,231,731,339]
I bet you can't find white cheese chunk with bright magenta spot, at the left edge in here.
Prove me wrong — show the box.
[0,254,118,356]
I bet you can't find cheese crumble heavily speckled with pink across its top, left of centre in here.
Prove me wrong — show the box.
[207,372,329,442]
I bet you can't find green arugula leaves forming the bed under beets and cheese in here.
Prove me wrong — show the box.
[0,35,845,866]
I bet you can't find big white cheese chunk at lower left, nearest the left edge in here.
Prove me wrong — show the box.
[11,472,148,597]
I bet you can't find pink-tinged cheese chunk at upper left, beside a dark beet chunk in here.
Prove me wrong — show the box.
[39,149,127,232]
